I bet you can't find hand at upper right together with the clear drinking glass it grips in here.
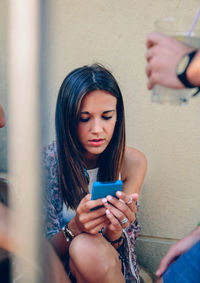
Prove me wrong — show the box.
[146,10,200,105]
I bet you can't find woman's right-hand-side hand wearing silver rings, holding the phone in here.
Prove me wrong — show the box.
[104,191,138,241]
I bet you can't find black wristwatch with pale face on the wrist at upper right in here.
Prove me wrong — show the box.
[176,50,197,88]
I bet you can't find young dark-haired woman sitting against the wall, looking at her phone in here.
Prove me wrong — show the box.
[44,64,147,283]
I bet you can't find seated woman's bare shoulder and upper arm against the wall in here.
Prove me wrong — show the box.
[121,147,147,194]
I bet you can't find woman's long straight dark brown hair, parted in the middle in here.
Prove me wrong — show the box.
[55,64,125,209]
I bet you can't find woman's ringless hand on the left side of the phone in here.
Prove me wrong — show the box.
[69,194,109,235]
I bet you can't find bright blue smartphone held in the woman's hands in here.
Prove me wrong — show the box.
[91,180,123,200]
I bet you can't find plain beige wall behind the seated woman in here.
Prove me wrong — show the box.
[43,0,200,278]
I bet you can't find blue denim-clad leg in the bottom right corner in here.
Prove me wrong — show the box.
[163,241,200,283]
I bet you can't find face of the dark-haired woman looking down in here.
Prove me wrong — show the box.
[78,90,117,163]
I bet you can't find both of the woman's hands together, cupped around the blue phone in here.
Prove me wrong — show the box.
[77,191,138,234]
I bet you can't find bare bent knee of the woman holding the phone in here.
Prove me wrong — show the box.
[69,234,125,283]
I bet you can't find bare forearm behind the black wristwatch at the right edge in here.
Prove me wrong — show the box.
[186,50,200,86]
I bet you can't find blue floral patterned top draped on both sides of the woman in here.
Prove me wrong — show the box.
[44,141,140,283]
